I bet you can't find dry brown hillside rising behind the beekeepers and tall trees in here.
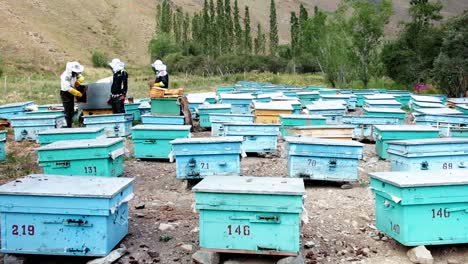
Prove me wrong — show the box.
[0,0,468,71]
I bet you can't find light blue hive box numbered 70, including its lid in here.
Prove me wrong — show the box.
[286,137,364,182]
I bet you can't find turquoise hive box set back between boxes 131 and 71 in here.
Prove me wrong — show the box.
[132,125,192,159]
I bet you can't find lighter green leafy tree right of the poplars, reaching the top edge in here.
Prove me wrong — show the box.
[347,0,392,88]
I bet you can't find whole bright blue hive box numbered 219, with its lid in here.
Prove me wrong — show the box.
[0,175,133,257]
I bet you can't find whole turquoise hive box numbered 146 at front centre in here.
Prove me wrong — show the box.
[192,176,305,256]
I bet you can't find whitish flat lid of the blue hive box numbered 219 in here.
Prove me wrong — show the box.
[0,174,134,198]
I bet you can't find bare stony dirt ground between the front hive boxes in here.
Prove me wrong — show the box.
[0,127,468,264]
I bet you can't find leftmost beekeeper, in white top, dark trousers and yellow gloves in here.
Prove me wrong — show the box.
[60,61,84,127]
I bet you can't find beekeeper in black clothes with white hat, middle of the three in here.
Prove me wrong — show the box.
[109,59,128,114]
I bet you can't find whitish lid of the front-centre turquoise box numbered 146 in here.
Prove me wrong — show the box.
[192,176,305,195]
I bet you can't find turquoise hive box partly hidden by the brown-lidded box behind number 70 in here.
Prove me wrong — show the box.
[280,114,327,137]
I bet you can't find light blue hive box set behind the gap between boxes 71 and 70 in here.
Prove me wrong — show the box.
[223,123,280,153]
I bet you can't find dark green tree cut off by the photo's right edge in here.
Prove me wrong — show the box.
[434,11,468,97]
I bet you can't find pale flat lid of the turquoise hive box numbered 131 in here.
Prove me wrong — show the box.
[37,138,123,150]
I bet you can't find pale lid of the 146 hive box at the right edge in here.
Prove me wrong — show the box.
[369,170,468,187]
